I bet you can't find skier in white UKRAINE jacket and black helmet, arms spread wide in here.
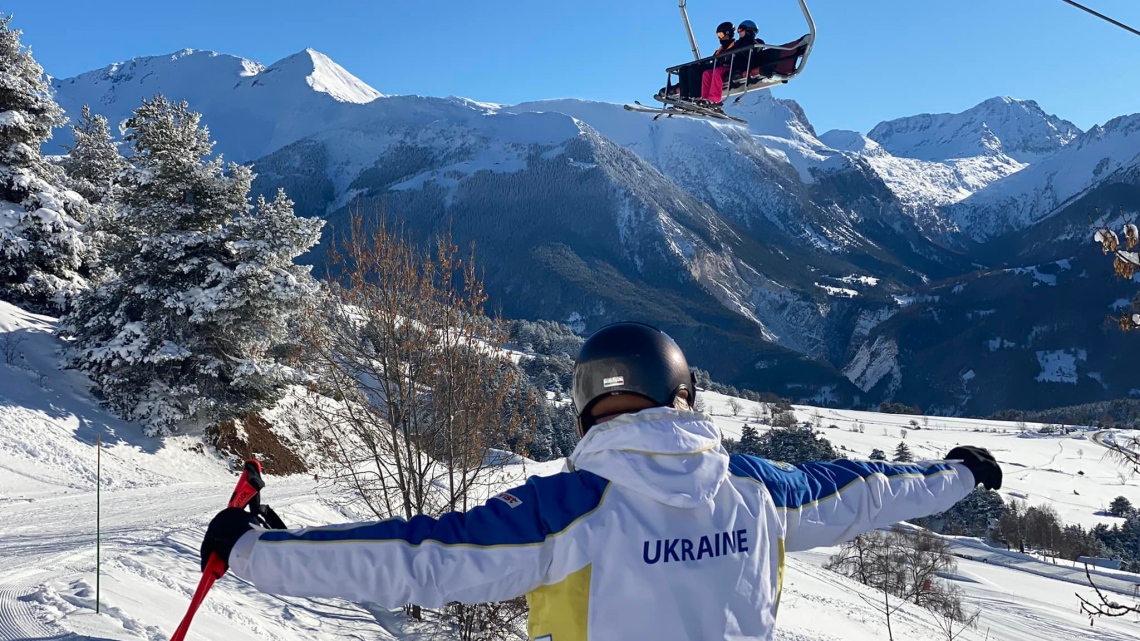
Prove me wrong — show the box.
[202,323,1001,641]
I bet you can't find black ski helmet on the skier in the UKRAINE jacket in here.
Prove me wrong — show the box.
[571,322,697,433]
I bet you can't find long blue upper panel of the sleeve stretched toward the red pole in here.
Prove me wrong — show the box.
[259,470,609,547]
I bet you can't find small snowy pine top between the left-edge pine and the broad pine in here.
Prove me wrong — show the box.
[62,105,130,204]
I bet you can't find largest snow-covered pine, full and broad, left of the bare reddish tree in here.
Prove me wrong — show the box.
[65,96,323,433]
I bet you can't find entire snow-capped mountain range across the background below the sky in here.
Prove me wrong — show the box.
[40,50,1140,412]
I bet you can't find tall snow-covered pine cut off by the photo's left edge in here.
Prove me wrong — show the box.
[0,16,87,311]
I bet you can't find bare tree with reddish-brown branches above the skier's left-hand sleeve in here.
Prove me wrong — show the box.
[296,211,536,627]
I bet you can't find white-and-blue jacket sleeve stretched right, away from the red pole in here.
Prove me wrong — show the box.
[731,455,975,551]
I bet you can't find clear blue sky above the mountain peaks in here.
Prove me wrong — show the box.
[0,0,1140,132]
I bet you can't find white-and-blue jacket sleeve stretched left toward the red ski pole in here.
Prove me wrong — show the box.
[229,474,601,607]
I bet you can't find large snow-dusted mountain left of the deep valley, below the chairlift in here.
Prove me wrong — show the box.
[55,51,948,381]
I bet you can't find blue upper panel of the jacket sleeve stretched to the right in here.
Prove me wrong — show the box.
[728,454,953,510]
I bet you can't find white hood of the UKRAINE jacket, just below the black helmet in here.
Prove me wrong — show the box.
[567,407,728,508]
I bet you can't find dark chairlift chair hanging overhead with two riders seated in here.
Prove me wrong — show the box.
[626,0,815,123]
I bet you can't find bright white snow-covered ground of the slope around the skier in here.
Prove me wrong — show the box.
[0,303,1140,641]
